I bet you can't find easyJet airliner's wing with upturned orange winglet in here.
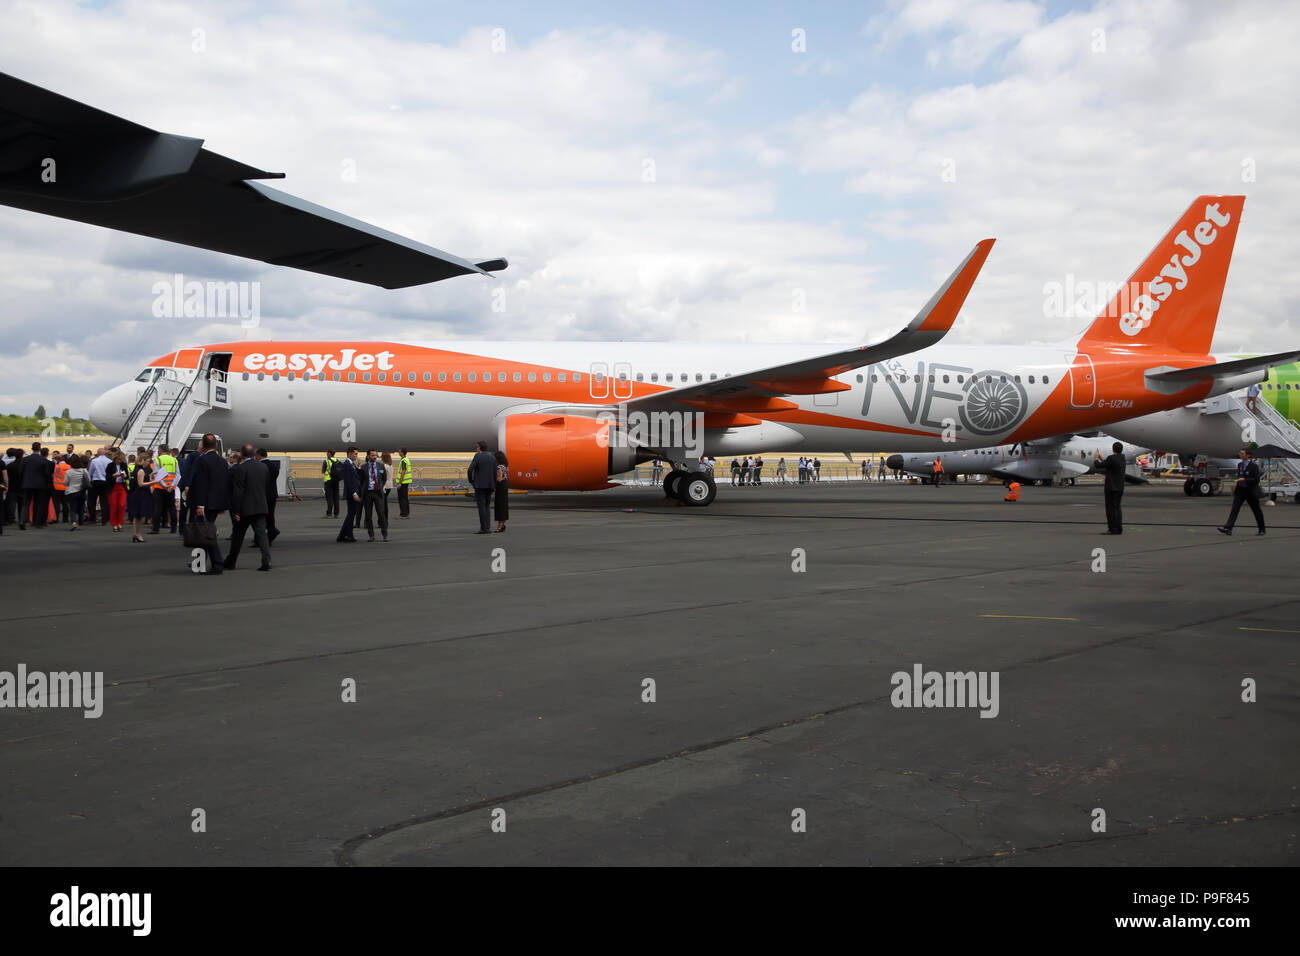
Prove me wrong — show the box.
[613,239,993,414]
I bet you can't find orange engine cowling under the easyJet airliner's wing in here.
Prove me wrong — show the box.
[497,414,644,492]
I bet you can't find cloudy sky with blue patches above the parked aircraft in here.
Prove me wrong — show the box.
[0,0,1300,415]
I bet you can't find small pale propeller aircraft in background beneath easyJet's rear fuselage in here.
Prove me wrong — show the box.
[885,434,1151,485]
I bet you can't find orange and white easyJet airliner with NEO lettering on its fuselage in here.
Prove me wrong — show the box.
[91,196,1300,505]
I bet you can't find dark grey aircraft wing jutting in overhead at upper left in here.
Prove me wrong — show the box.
[0,73,506,289]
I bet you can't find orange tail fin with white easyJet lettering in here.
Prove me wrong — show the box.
[1079,196,1245,355]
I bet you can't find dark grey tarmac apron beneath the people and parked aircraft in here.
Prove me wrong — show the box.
[0,483,1300,866]
